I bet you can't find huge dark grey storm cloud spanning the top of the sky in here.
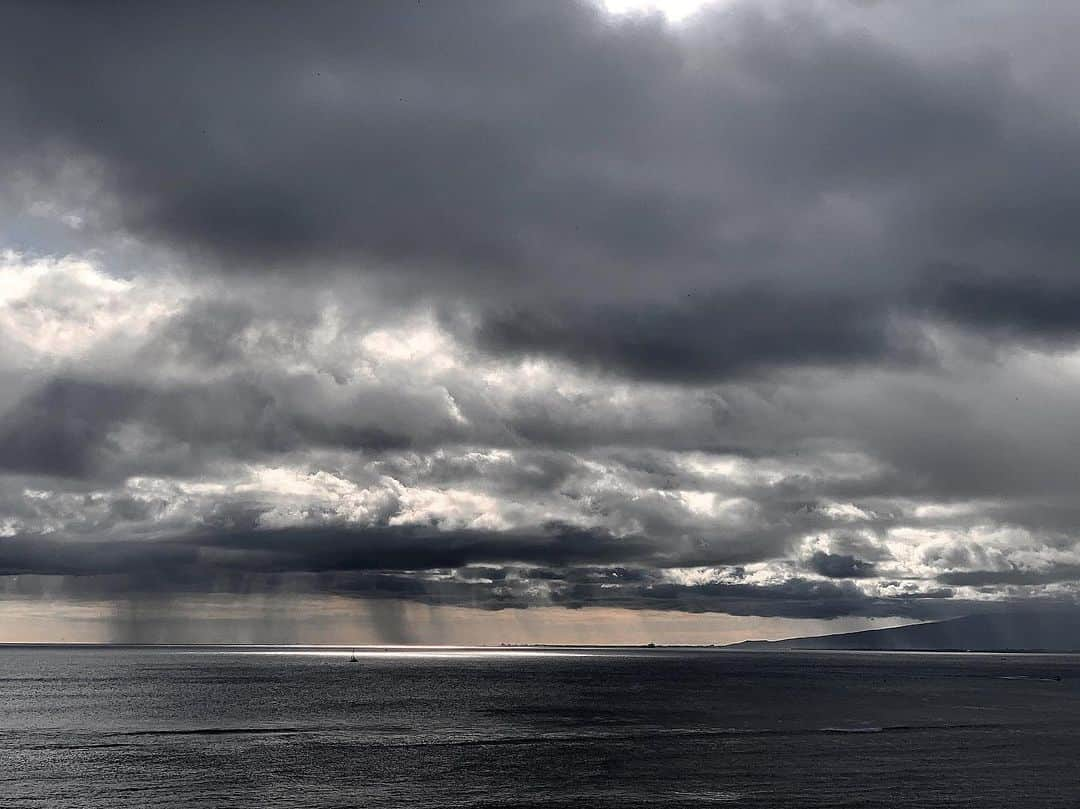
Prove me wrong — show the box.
[6,2,1080,380]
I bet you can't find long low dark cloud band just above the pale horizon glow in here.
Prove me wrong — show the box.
[0,527,972,619]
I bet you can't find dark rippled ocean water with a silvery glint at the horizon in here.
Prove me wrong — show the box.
[0,648,1080,809]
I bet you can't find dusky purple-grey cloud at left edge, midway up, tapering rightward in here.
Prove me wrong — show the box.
[0,371,434,480]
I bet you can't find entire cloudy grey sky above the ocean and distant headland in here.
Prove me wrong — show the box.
[0,0,1080,643]
